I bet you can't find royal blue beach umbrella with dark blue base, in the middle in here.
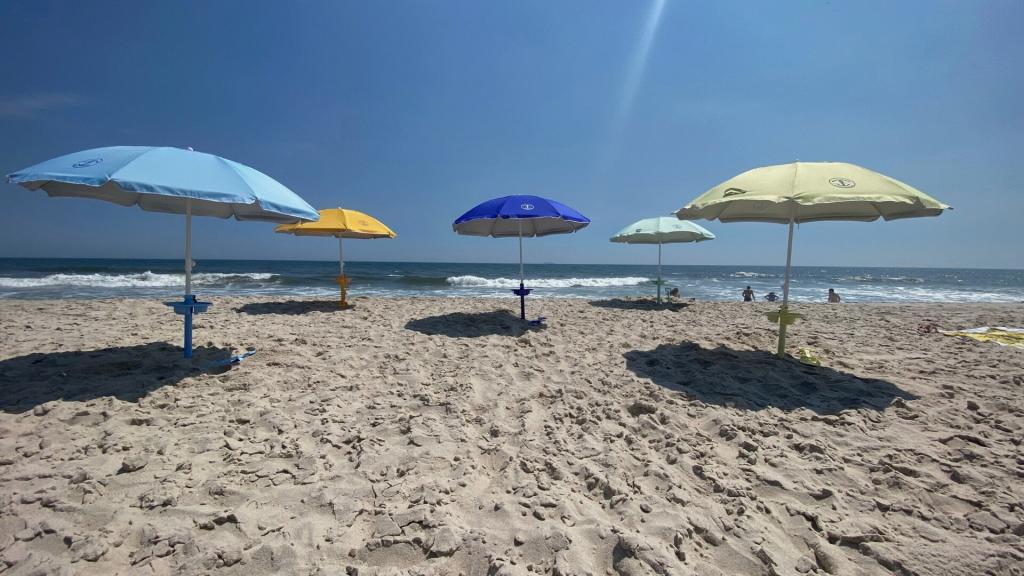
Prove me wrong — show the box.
[452,196,590,320]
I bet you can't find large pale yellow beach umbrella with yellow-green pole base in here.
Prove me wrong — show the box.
[676,162,949,356]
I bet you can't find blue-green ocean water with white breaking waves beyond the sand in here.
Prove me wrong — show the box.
[0,258,1024,302]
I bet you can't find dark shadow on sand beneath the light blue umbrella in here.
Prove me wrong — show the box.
[0,342,232,414]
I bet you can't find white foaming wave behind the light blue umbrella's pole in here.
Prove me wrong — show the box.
[0,272,278,288]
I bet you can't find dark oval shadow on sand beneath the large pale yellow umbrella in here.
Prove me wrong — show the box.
[625,342,918,414]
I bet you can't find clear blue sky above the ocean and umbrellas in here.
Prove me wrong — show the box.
[0,0,1024,268]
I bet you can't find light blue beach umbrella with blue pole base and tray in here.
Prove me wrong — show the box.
[7,146,319,358]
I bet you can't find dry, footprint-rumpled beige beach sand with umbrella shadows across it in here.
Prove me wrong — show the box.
[0,298,1024,576]
